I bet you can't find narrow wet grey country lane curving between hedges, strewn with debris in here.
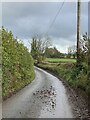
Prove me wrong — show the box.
[2,67,73,118]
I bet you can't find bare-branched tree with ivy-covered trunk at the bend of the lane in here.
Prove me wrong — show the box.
[31,35,51,62]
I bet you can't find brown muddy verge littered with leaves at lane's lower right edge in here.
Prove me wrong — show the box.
[63,83,90,119]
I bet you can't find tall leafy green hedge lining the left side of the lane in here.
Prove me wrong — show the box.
[1,27,34,98]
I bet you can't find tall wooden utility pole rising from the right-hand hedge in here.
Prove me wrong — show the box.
[77,0,81,65]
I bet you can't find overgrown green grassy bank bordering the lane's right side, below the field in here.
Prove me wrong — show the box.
[38,63,89,93]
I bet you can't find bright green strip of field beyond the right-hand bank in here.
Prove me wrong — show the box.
[46,58,76,63]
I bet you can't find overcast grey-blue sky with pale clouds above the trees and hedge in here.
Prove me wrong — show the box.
[2,0,88,53]
